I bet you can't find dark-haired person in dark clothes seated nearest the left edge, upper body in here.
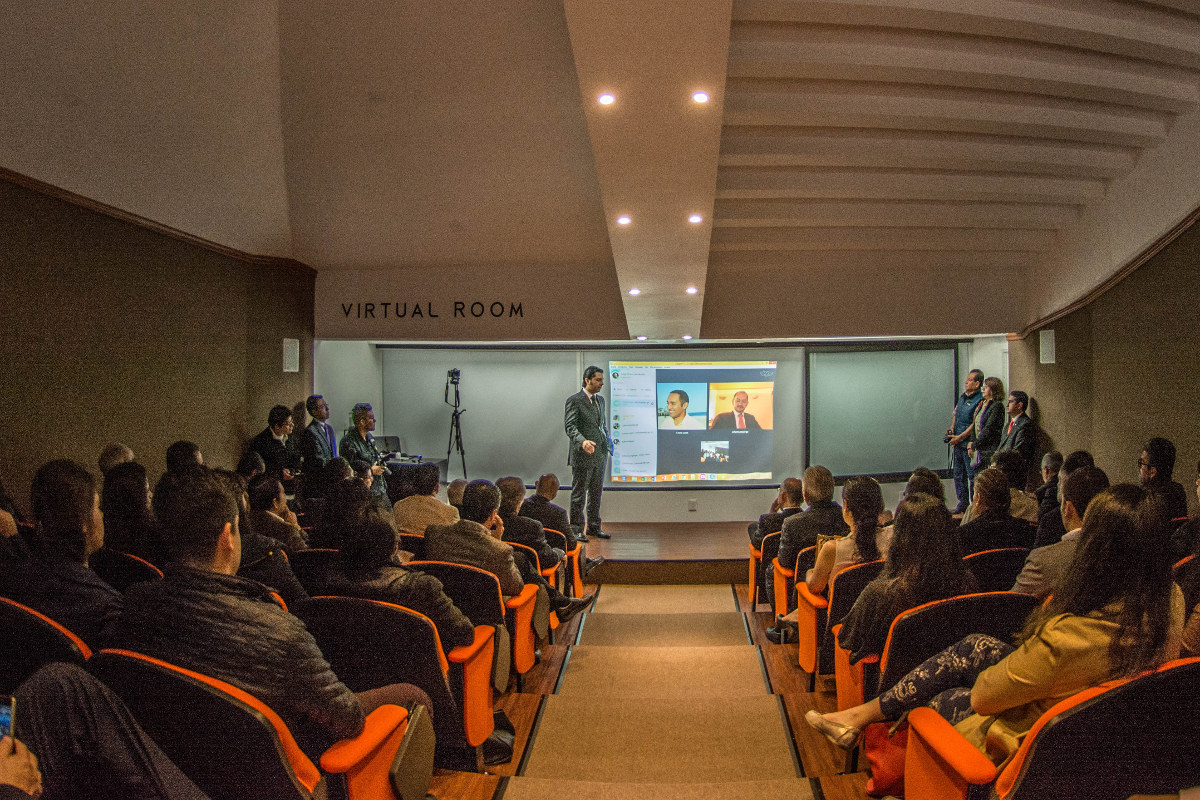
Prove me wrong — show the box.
[0,459,121,649]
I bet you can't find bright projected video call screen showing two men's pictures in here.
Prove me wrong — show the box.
[608,361,775,483]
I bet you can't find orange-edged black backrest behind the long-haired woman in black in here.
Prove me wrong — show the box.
[871,591,1040,693]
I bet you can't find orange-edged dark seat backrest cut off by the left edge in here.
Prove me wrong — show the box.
[0,597,91,696]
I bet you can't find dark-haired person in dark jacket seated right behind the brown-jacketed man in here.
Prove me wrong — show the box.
[325,505,475,652]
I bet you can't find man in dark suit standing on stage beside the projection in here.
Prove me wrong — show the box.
[563,367,612,541]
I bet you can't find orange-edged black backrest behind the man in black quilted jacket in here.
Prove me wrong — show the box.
[88,650,320,800]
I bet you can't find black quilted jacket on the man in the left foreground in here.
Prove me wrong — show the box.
[114,564,364,758]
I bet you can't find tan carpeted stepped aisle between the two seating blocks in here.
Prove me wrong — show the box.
[504,585,812,800]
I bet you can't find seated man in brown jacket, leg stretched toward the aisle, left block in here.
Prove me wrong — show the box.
[425,481,592,622]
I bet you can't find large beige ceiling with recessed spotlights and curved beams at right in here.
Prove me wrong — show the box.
[0,0,1200,341]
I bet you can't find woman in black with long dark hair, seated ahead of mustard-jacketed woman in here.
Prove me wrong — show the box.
[838,491,976,664]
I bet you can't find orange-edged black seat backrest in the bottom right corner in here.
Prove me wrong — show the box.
[996,658,1200,800]
